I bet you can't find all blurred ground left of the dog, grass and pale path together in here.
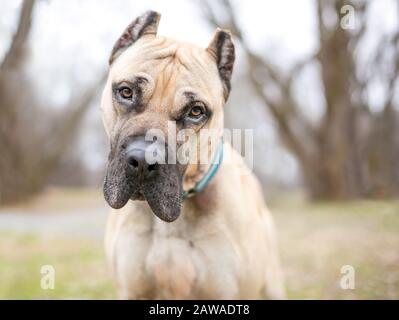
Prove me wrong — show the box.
[0,189,116,299]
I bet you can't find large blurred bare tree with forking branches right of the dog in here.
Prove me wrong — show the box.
[202,0,399,199]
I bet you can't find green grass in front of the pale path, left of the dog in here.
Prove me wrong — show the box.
[0,232,116,299]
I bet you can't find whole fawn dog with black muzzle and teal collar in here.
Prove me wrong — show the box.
[101,11,284,299]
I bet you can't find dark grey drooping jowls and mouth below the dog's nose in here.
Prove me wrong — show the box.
[104,158,183,222]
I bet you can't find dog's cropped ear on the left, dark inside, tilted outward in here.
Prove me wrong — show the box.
[109,11,161,64]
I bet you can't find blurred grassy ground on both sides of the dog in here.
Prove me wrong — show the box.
[0,190,399,299]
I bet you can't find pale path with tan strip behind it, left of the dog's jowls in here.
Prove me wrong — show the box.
[0,190,108,238]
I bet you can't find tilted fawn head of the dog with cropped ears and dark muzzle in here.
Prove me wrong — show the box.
[101,11,234,221]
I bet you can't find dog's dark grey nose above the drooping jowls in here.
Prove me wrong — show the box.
[125,138,157,178]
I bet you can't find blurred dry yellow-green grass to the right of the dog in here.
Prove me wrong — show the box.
[269,196,399,299]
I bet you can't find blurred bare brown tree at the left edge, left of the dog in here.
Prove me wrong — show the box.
[0,0,104,204]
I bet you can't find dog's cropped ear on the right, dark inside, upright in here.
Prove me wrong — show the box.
[206,28,235,100]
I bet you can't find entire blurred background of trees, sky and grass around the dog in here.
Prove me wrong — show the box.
[0,0,399,299]
